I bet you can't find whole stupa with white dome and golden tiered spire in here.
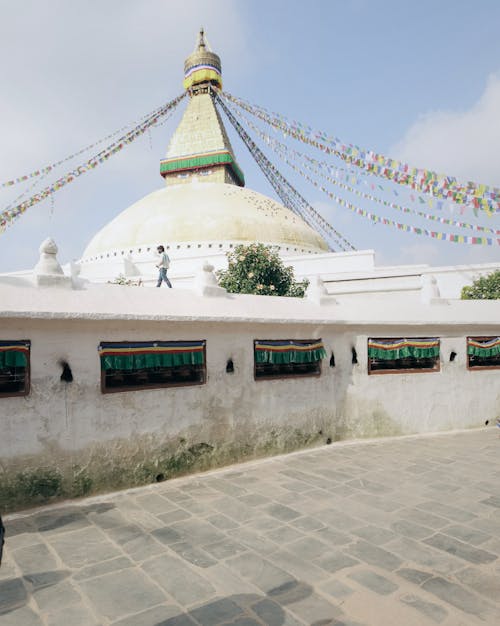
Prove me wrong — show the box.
[79,29,329,284]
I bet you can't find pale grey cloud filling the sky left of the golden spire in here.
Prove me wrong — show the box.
[0,0,249,271]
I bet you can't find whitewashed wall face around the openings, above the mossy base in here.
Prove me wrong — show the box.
[0,320,500,459]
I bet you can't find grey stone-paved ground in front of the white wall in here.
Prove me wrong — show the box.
[0,428,500,626]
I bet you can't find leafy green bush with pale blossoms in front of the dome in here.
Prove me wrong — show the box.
[217,243,309,298]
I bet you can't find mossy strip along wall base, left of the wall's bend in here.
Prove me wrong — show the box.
[0,424,330,513]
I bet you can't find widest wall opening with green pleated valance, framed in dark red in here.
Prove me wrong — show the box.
[99,340,207,393]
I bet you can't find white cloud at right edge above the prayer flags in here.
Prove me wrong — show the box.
[390,74,500,187]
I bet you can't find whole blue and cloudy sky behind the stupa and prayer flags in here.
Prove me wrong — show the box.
[0,0,500,272]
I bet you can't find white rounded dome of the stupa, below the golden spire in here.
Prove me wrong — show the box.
[82,180,328,262]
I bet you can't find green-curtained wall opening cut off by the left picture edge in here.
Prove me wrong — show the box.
[0,339,31,397]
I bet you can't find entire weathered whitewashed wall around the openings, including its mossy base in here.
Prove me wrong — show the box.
[0,319,500,510]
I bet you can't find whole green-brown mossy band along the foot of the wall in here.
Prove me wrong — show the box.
[0,402,418,513]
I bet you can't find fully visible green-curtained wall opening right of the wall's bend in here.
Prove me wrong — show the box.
[368,337,440,374]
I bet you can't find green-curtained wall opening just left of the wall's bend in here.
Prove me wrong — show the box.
[254,339,327,380]
